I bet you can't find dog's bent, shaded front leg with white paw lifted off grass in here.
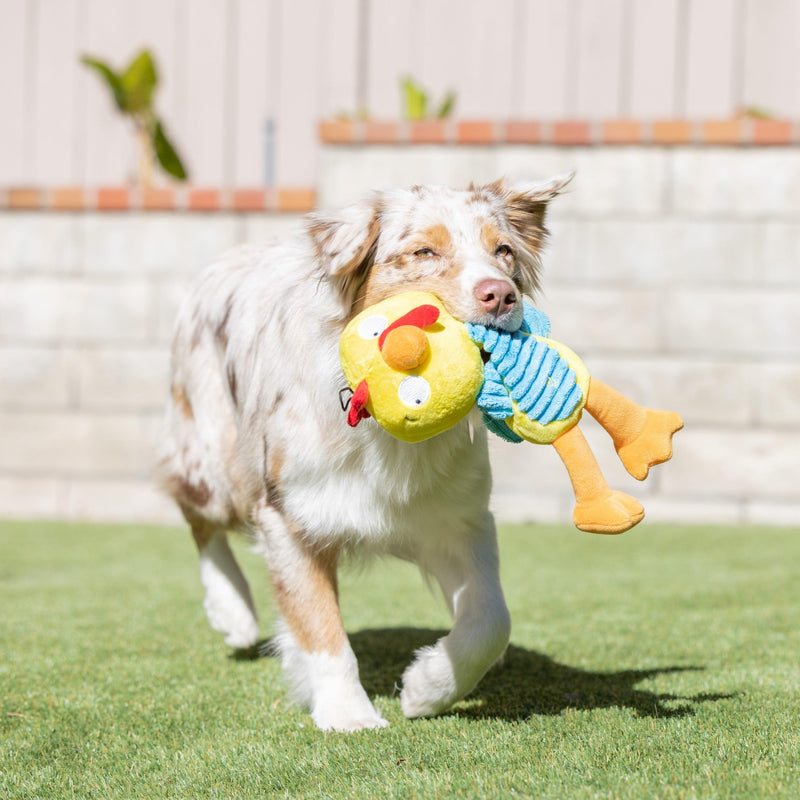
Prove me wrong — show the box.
[400,512,511,717]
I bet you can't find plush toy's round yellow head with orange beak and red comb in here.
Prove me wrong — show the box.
[339,292,483,442]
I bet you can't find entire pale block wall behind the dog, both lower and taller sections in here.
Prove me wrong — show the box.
[0,144,800,524]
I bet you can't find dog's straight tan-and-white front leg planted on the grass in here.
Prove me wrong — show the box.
[259,508,388,731]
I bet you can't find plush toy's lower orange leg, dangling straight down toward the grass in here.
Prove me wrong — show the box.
[553,425,644,533]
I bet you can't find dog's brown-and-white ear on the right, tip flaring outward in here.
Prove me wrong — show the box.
[485,172,575,294]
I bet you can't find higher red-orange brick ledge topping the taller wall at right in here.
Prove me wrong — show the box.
[318,118,800,146]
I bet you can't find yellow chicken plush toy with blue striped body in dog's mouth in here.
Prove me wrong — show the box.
[340,292,683,533]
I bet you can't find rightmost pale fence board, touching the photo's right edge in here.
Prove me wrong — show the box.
[742,0,800,117]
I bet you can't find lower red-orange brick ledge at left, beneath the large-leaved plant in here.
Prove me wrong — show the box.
[0,186,316,214]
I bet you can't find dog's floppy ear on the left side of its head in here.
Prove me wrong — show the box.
[306,194,381,302]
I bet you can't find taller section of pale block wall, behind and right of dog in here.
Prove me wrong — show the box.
[319,143,800,525]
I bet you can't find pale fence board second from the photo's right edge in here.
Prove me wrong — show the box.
[678,0,739,117]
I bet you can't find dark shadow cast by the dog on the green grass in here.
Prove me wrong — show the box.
[231,628,733,721]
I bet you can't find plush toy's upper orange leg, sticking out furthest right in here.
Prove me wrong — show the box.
[586,378,683,481]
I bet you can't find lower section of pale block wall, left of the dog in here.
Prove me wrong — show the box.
[0,210,299,522]
